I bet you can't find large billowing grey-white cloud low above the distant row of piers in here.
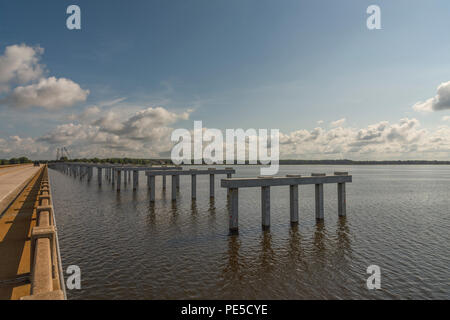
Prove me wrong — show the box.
[31,107,191,157]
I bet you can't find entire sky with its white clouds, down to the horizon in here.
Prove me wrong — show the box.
[0,0,450,160]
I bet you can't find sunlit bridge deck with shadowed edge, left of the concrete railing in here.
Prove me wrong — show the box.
[0,166,40,300]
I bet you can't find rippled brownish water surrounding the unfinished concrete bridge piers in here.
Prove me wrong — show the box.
[49,166,450,299]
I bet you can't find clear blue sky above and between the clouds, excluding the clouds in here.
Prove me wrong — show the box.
[0,0,450,158]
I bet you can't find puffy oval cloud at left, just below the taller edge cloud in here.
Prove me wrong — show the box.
[1,77,89,110]
